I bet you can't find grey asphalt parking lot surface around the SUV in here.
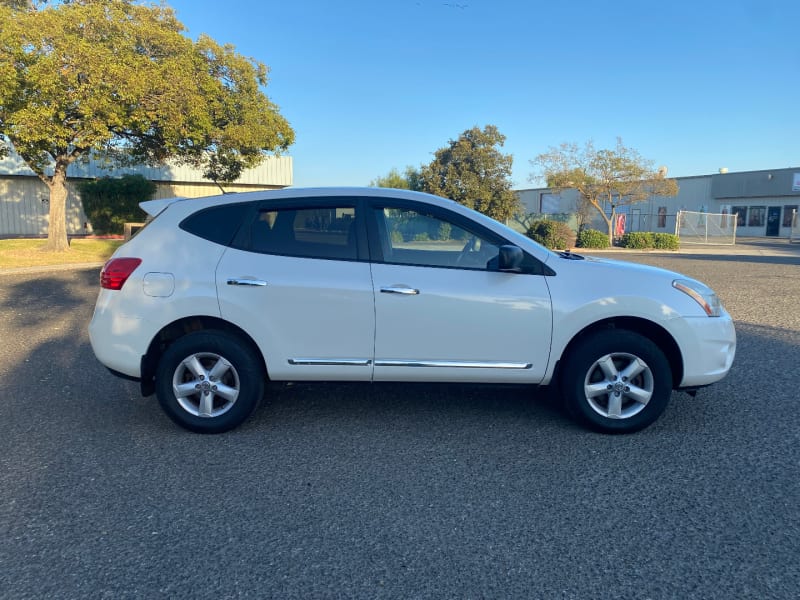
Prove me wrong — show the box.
[0,246,800,599]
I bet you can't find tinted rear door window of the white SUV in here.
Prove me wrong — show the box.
[250,207,358,260]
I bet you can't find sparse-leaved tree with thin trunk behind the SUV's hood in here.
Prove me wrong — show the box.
[530,138,678,242]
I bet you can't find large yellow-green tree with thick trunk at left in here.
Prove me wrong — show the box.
[0,0,294,250]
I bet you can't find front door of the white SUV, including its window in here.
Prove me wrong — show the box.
[372,203,552,383]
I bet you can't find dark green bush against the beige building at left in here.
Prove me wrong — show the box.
[78,175,156,234]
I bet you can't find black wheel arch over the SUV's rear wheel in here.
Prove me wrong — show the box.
[141,315,269,396]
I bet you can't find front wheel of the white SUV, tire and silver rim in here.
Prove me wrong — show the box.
[559,329,672,433]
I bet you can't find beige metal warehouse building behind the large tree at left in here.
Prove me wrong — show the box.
[0,153,292,237]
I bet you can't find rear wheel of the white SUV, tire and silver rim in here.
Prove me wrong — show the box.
[156,330,266,433]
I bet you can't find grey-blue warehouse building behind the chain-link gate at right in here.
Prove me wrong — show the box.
[516,167,800,237]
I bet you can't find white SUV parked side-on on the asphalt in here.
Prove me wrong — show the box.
[89,188,736,433]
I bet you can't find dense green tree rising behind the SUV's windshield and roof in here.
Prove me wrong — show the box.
[418,125,521,222]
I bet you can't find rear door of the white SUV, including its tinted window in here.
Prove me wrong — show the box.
[216,198,375,381]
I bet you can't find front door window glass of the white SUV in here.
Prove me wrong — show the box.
[375,208,498,269]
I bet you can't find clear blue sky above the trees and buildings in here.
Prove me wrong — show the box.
[168,0,800,189]
